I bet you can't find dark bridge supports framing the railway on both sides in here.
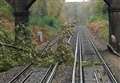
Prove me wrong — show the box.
[6,0,120,52]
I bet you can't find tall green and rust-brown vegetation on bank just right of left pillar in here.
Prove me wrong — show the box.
[29,0,64,44]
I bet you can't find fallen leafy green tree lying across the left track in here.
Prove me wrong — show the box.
[0,23,73,72]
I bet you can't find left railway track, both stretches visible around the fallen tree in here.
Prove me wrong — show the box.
[8,38,58,83]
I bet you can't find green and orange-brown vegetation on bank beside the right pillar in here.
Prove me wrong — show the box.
[88,0,109,41]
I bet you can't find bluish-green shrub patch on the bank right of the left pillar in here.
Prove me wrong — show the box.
[30,15,60,28]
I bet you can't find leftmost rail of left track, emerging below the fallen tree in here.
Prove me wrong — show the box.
[8,63,32,83]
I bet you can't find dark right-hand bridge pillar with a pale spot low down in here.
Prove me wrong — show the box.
[104,0,120,52]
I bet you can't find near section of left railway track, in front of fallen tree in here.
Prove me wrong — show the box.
[8,63,59,83]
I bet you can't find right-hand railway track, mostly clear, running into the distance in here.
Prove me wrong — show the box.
[72,28,118,83]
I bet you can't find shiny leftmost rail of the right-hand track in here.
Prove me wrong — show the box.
[72,32,79,83]
